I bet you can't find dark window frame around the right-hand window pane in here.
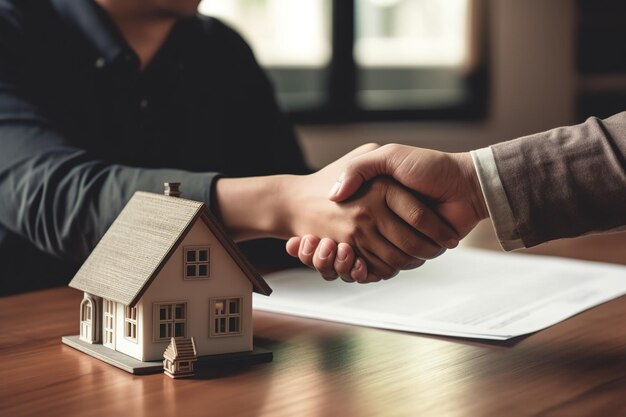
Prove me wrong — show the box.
[265,0,489,124]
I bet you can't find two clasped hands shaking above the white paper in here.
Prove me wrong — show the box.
[286,144,488,283]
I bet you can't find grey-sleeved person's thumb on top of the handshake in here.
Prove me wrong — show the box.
[328,148,388,202]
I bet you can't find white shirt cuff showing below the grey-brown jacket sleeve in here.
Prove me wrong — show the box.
[470,148,524,251]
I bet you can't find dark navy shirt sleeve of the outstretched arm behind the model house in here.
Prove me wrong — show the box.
[0,19,217,261]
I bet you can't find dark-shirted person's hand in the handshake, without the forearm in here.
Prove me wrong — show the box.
[287,146,459,282]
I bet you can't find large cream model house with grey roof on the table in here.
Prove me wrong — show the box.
[63,184,271,373]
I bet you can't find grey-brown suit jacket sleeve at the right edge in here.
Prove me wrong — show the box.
[486,112,626,247]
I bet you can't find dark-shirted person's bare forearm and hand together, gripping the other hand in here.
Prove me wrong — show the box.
[213,145,460,282]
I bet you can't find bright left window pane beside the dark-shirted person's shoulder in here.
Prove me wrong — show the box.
[199,0,332,111]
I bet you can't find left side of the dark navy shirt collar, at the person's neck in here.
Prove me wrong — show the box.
[51,0,138,66]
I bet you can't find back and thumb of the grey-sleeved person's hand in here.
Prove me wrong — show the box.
[329,144,488,239]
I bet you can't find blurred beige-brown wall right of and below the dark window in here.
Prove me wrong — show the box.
[298,0,575,167]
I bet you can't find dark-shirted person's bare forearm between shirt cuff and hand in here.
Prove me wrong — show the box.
[213,175,298,241]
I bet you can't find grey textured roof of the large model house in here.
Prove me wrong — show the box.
[69,192,272,306]
